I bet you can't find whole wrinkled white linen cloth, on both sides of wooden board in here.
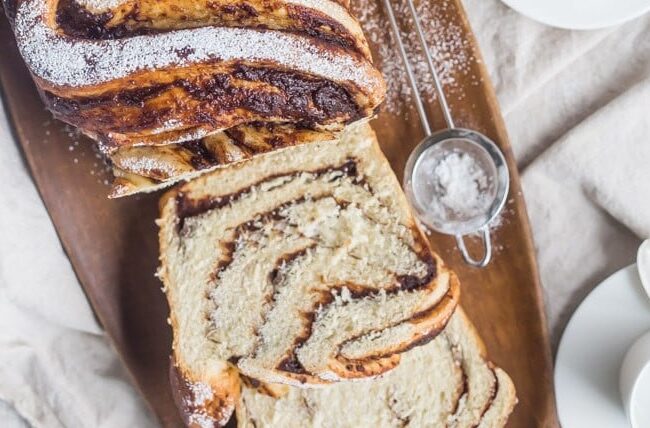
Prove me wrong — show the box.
[0,0,650,428]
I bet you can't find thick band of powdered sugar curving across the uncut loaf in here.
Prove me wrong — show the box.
[16,0,381,92]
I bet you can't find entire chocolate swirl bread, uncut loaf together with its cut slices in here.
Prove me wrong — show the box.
[4,0,516,427]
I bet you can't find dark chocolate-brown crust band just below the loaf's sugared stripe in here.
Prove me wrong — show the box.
[36,62,377,149]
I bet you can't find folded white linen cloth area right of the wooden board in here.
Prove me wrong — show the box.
[465,0,650,347]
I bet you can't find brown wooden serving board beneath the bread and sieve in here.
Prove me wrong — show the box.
[0,0,558,427]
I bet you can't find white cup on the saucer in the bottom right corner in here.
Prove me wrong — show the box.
[619,331,650,428]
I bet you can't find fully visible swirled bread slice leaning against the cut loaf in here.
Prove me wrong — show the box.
[159,124,458,422]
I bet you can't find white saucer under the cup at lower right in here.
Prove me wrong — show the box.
[555,265,650,428]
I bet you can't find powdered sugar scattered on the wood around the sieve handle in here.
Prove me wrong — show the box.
[353,0,481,113]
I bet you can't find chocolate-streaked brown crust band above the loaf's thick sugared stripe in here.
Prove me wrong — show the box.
[52,0,371,59]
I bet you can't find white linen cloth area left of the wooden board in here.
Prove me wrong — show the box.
[0,104,156,428]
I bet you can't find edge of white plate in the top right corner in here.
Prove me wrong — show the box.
[502,0,650,30]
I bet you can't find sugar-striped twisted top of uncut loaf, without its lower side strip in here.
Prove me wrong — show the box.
[8,0,384,148]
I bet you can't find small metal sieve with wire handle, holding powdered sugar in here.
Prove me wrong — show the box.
[383,0,510,267]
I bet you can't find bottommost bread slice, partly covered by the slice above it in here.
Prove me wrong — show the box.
[236,308,517,428]
